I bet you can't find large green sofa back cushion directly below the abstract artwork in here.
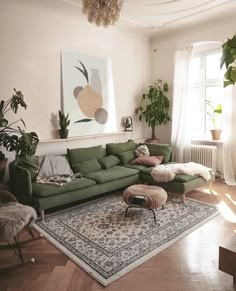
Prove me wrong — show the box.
[67,145,106,167]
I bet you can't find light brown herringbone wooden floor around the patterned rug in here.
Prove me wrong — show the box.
[0,181,236,291]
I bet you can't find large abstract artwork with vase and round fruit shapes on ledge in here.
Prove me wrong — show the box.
[62,51,117,137]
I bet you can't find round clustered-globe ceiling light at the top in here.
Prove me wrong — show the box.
[82,0,124,27]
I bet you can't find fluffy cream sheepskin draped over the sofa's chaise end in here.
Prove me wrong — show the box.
[151,162,211,182]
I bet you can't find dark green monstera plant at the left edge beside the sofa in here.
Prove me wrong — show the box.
[0,89,39,183]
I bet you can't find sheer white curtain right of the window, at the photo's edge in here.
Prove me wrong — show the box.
[222,86,236,185]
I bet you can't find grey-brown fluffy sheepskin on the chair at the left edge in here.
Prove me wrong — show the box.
[0,202,37,241]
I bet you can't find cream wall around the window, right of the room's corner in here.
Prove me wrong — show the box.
[151,16,236,170]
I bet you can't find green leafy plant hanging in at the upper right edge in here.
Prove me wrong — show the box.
[220,35,236,87]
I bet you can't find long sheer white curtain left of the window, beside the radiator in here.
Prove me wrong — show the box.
[171,46,193,163]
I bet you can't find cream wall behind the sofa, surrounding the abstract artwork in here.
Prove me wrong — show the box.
[0,0,150,159]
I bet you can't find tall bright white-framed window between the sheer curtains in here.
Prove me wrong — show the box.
[191,49,223,137]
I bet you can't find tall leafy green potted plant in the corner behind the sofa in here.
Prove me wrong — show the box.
[135,79,171,142]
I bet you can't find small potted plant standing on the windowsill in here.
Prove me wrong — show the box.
[206,100,222,140]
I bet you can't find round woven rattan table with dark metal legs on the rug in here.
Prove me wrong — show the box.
[123,184,167,222]
